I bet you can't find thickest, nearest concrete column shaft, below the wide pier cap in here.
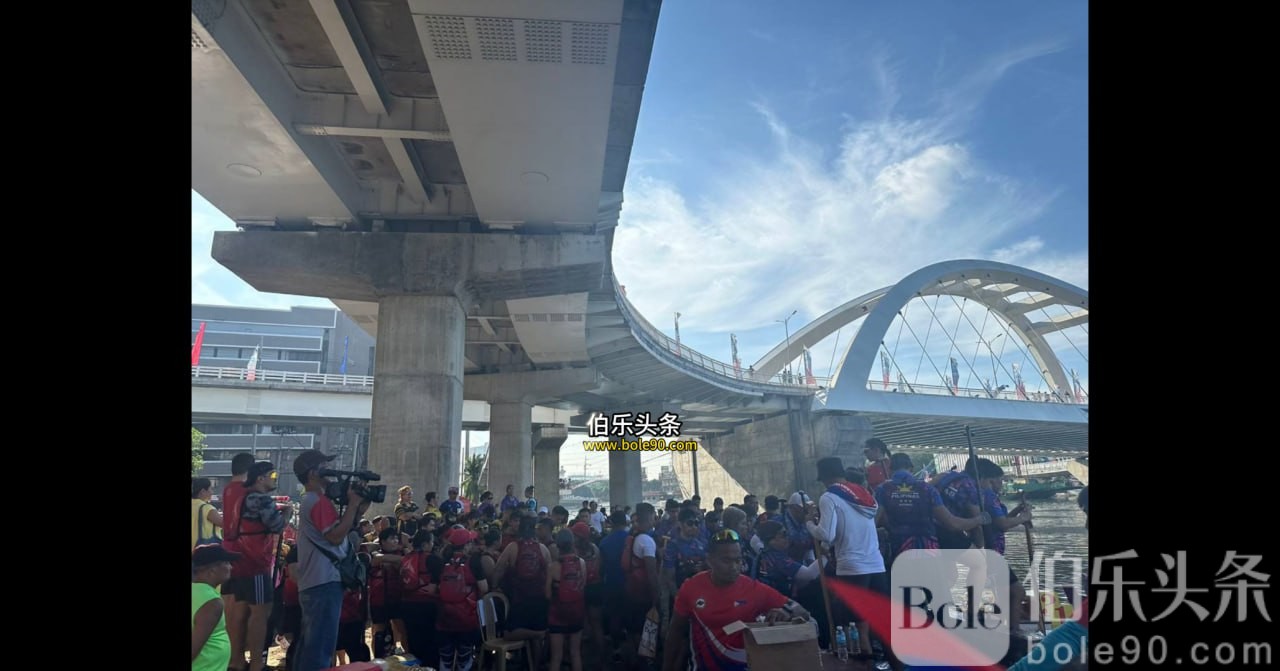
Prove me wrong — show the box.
[369,296,466,512]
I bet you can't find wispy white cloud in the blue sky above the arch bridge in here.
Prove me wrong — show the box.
[614,42,1088,371]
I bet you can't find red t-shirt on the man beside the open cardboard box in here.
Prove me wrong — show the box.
[676,571,788,671]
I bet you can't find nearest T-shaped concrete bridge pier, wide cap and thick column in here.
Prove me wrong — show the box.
[212,229,607,513]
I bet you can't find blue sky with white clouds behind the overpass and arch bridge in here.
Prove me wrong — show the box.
[192,0,1089,478]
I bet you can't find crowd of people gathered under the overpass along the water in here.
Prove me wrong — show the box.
[192,438,1090,671]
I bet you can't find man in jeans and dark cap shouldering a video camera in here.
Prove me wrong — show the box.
[293,449,369,671]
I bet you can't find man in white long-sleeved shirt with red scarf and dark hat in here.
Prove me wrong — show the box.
[806,457,888,651]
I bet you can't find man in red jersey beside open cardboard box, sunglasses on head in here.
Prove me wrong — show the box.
[662,529,809,671]
